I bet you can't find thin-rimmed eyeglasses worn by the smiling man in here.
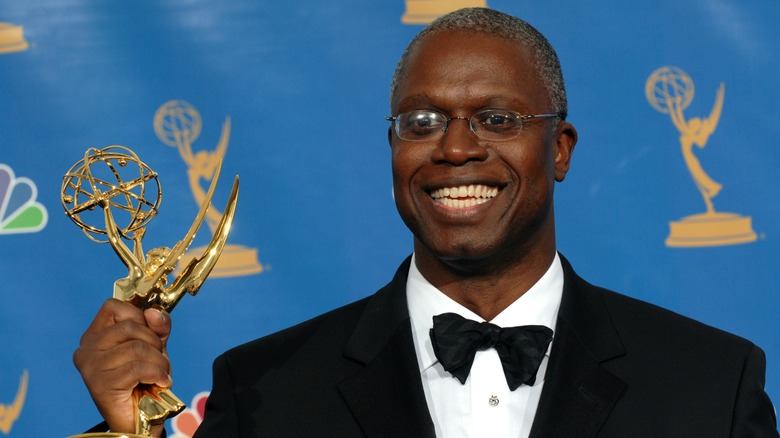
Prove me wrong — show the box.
[385,109,561,141]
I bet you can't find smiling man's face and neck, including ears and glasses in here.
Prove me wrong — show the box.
[390,16,577,320]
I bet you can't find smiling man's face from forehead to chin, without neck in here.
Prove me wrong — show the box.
[389,32,577,269]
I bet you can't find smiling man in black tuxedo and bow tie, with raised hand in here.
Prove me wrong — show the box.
[74,9,777,437]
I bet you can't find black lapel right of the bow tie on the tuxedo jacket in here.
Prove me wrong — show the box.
[530,257,627,438]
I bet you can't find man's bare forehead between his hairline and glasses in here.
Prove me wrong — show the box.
[391,31,550,112]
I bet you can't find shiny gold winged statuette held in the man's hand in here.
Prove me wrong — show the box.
[62,145,238,438]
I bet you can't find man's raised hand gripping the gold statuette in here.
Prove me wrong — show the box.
[73,298,173,436]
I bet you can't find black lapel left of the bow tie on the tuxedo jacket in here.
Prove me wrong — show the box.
[339,259,435,437]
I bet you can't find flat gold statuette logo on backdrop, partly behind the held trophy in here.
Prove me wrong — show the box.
[154,100,263,277]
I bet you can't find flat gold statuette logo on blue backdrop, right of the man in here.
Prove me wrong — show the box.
[645,67,757,247]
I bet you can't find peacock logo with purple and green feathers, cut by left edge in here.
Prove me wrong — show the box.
[0,163,49,234]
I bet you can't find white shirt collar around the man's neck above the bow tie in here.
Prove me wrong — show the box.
[406,252,563,372]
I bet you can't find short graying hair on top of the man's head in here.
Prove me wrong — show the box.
[390,8,568,119]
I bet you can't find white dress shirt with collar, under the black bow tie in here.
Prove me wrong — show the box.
[406,253,563,438]
